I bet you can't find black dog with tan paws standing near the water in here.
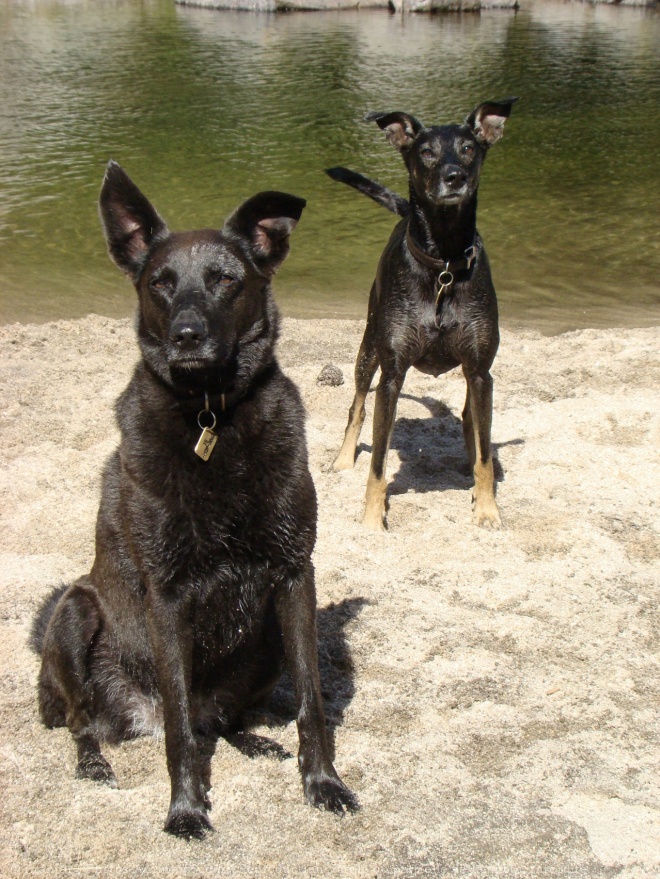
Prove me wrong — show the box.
[328,98,517,530]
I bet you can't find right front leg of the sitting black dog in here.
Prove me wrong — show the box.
[275,564,358,814]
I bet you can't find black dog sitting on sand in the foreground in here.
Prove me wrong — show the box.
[33,162,357,838]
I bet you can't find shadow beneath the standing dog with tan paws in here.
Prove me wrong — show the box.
[360,394,524,495]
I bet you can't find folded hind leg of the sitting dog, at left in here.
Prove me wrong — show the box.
[39,580,117,787]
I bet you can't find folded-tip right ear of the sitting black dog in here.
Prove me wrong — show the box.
[223,192,307,275]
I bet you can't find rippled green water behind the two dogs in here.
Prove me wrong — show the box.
[0,0,660,332]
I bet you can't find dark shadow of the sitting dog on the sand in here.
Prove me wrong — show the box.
[225,598,369,760]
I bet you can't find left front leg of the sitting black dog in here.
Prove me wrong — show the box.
[147,590,213,839]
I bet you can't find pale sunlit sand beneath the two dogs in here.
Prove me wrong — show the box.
[0,316,660,879]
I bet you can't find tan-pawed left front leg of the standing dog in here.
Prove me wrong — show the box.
[362,371,405,531]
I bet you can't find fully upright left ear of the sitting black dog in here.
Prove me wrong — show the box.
[99,161,169,281]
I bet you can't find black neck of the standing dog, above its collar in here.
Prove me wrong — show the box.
[408,186,477,260]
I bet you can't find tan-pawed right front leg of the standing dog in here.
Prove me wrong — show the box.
[464,371,502,528]
